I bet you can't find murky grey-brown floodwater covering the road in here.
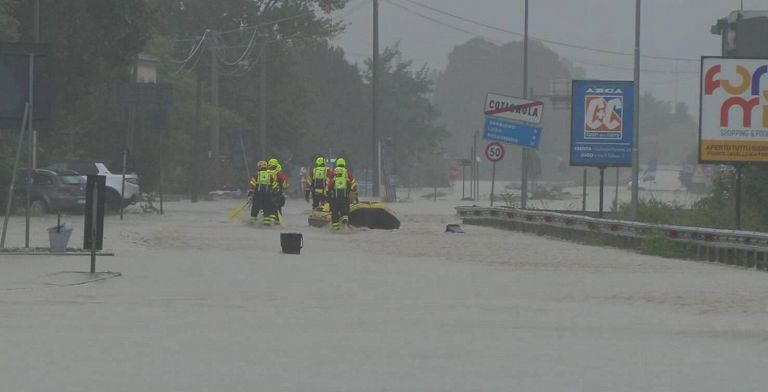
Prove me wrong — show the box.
[0,200,768,392]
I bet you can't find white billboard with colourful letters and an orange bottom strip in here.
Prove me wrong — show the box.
[699,57,768,163]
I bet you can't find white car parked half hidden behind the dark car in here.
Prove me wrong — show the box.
[46,161,141,210]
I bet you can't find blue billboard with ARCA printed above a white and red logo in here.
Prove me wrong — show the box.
[571,80,635,167]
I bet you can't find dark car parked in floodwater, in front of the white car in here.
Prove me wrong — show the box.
[14,169,85,214]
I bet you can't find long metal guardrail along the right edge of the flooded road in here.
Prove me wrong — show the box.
[456,206,768,271]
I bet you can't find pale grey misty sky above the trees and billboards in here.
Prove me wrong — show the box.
[336,0,756,113]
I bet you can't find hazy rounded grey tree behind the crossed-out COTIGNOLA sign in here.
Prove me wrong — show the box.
[435,38,578,177]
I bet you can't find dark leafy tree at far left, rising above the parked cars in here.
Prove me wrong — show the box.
[14,0,152,163]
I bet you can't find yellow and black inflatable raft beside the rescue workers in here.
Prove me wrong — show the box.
[309,201,400,230]
